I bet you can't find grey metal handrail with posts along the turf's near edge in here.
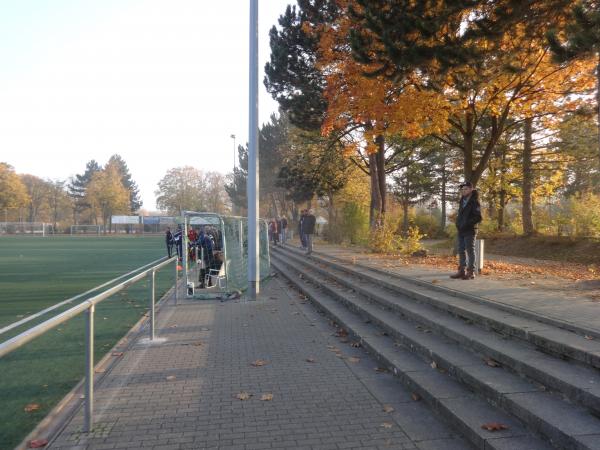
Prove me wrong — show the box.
[0,256,178,432]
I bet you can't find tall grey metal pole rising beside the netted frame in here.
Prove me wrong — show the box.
[247,0,260,300]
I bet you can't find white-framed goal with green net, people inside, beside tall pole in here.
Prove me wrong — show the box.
[178,211,270,299]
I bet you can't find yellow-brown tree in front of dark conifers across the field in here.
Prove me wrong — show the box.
[85,164,130,233]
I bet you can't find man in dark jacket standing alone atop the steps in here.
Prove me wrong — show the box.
[450,181,481,280]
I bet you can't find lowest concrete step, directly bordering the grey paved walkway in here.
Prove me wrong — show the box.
[271,253,554,450]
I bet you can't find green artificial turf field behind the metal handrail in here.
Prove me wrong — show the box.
[0,235,174,450]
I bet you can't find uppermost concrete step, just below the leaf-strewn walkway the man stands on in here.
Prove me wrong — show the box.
[277,247,600,369]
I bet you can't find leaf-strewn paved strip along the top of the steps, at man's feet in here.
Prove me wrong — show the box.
[315,245,600,333]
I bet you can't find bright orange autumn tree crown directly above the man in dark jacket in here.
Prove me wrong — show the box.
[349,0,587,183]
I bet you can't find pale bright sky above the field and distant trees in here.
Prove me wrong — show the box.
[0,0,294,211]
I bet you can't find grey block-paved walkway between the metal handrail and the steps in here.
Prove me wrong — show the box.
[50,277,470,450]
